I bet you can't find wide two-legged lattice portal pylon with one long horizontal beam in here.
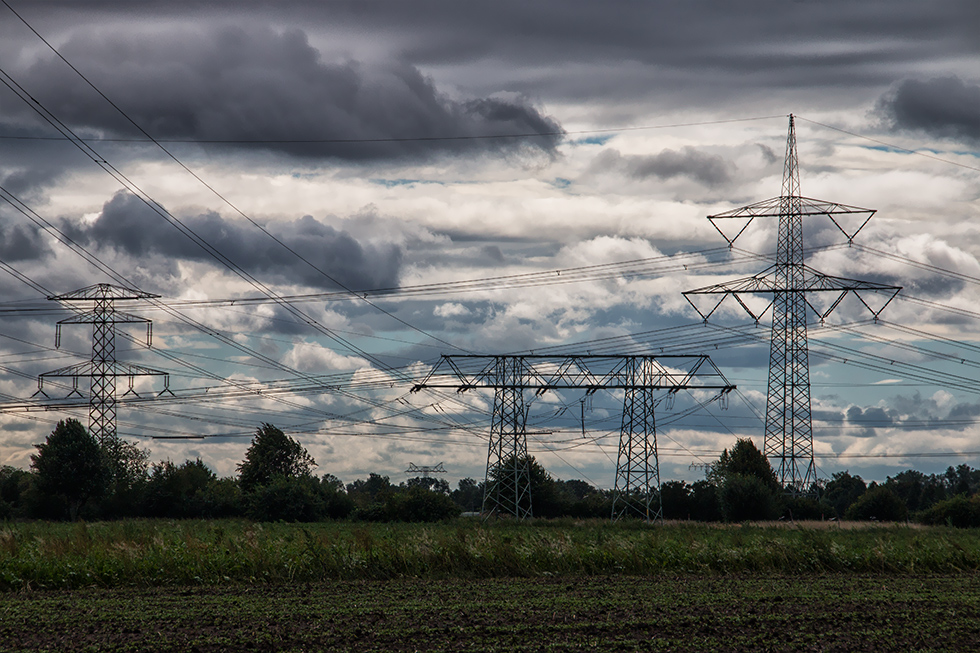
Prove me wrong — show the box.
[412,355,735,521]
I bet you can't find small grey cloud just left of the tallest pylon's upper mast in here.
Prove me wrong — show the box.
[592,146,735,186]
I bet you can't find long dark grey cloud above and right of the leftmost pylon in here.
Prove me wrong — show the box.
[63,192,402,289]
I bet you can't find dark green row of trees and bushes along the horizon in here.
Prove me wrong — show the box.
[0,419,980,527]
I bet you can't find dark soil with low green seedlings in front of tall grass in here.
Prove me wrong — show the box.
[0,575,980,652]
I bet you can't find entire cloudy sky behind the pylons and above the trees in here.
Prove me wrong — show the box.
[0,0,980,487]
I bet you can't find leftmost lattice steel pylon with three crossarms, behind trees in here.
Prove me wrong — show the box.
[38,283,170,446]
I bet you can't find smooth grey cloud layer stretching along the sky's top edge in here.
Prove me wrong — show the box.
[9,0,980,117]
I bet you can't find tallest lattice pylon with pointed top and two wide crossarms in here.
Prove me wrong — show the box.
[684,115,901,492]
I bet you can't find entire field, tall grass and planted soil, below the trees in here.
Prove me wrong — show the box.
[0,520,980,651]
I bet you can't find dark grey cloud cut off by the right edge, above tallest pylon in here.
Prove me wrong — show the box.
[878,77,980,144]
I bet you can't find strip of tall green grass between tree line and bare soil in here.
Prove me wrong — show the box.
[0,520,980,591]
